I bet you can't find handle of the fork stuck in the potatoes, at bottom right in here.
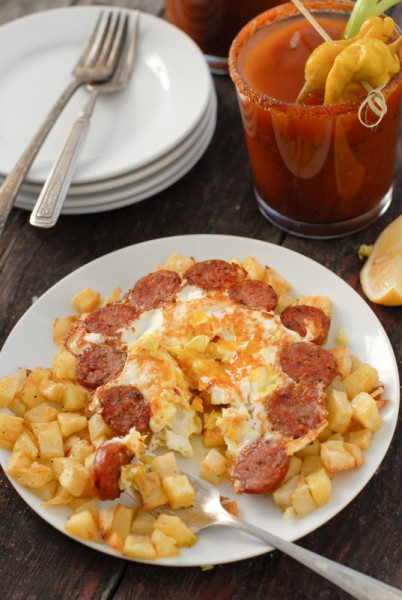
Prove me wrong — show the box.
[225,517,402,600]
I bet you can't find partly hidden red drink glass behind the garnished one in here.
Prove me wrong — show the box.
[165,0,285,74]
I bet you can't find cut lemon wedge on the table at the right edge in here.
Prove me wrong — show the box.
[360,215,402,306]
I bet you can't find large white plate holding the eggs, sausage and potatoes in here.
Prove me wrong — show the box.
[0,235,399,566]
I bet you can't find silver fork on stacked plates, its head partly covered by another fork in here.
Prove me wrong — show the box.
[30,11,141,228]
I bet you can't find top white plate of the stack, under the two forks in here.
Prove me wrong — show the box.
[0,6,211,183]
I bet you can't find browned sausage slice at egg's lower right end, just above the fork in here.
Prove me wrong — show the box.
[231,439,289,494]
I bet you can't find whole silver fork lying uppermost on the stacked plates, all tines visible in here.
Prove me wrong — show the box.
[0,11,126,237]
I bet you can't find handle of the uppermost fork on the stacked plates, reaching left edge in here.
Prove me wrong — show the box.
[0,79,83,238]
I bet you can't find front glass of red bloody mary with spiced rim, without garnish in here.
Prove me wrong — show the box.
[229,0,402,238]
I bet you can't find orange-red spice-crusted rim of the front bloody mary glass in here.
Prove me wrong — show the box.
[229,0,402,118]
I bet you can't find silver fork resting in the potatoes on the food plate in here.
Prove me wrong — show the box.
[126,469,402,600]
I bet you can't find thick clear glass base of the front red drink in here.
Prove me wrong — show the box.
[254,186,393,239]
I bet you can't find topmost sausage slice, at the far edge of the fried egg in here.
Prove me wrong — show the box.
[183,259,246,290]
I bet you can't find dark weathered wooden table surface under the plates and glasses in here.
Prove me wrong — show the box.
[0,0,402,600]
